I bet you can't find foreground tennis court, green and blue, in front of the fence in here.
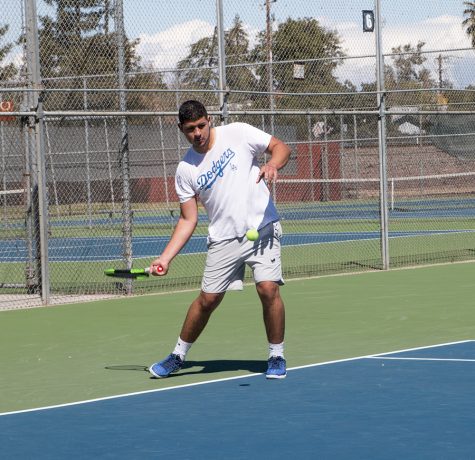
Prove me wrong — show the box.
[0,262,475,459]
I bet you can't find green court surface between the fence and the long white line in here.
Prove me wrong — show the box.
[0,262,475,413]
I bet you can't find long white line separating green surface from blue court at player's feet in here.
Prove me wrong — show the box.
[0,339,475,417]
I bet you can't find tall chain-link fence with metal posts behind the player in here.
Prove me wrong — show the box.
[0,0,475,308]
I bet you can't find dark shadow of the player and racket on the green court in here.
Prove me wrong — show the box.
[105,359,267,378]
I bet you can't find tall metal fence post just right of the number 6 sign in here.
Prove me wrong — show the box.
[375,0,389,270]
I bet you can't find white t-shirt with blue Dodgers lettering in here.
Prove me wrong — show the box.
[175,123,279,241]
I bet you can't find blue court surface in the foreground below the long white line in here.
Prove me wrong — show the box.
[0,340,475,459]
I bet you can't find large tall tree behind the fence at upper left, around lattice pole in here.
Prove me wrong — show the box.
[39,0,165,110]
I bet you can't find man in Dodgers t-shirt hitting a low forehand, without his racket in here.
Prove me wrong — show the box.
[149,100,290,379]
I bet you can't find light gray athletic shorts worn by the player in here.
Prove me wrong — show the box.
[201,222,284,294]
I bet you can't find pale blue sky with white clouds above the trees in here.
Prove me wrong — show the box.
[0,0,475,87]
